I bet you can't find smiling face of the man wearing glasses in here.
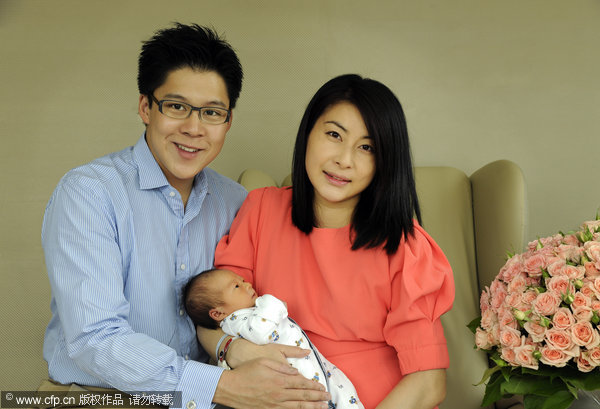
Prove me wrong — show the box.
[139,67,231,196]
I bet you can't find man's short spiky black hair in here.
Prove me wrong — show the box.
[138,23,244,109]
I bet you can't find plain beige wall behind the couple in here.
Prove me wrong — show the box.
[0,0,600,386]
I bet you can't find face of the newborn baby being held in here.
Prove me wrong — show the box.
[213,270,257,314]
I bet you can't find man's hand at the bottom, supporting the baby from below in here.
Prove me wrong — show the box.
[213,358,331,409]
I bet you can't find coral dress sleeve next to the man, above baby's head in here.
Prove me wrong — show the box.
[215,189,265,285]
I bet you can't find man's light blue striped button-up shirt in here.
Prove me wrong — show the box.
[42,136,246,408]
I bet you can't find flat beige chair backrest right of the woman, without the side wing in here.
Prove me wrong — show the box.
[415,167,488,409]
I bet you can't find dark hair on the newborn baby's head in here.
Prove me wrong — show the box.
[183,268,223,329]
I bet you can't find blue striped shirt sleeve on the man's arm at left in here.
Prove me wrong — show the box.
[42,178,222,408]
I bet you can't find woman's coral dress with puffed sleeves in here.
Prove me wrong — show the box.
[215,188,454,409]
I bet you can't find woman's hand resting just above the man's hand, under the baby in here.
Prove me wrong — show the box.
[226,338,310,368]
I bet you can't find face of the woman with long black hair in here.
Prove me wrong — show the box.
[305,101,375,217]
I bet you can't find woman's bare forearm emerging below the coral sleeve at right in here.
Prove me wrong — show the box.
[377,369,446,409]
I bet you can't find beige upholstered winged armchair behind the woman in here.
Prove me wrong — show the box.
[239,160,526,409]
